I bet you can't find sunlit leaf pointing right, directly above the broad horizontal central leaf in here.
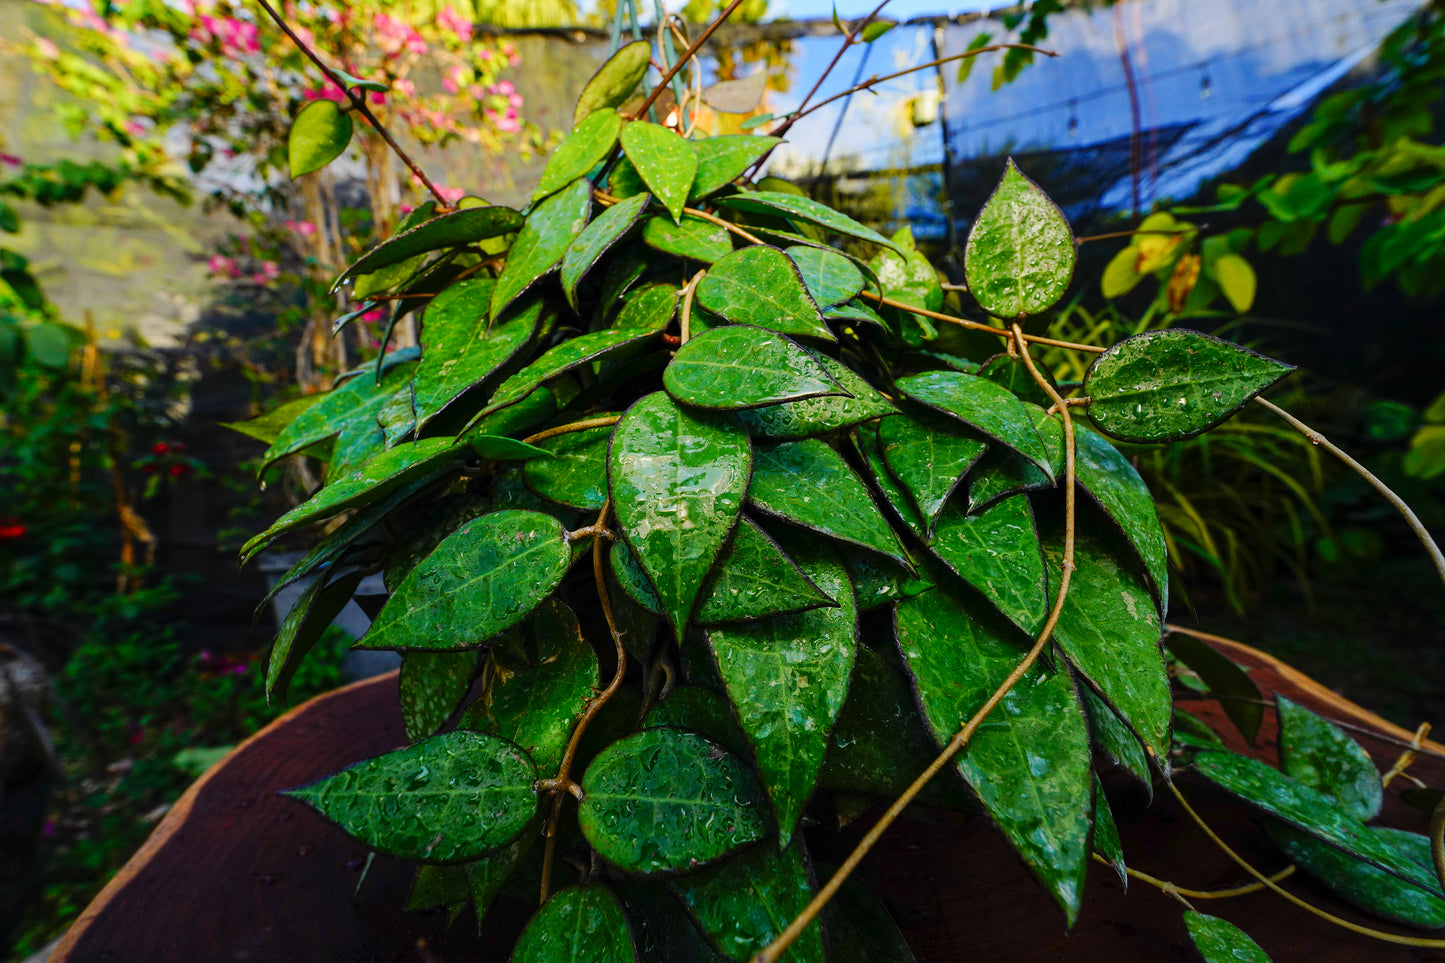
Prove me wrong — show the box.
[696,244,837,341]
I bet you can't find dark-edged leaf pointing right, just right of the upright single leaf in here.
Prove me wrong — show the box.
[1084,328,1295,442]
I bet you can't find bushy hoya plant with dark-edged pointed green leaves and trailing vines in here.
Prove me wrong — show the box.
[231,3,1445,963]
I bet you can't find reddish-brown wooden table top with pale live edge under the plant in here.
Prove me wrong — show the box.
[51,638,1445,963]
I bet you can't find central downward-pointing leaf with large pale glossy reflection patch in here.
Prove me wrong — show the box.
[607,392,753,639]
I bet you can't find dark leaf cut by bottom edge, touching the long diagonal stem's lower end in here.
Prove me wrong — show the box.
[672,840,825,963]
